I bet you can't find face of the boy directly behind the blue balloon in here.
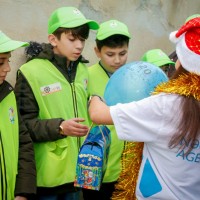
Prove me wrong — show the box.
[95,44,128,73]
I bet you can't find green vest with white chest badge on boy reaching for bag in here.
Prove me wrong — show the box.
[20,59,89,187]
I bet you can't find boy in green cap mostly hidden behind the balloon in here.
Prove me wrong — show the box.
[141,49,175,78]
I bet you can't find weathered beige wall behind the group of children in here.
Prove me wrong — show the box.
[0,0,200,85]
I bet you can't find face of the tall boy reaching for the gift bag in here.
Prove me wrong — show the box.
[51,32,85,61]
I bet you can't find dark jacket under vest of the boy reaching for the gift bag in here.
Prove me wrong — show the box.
[15,42,90,194]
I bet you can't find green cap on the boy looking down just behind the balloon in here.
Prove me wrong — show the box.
[96,20,131,40]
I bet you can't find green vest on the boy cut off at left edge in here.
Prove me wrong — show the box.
[0,91,19,200]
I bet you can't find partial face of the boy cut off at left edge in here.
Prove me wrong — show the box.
[0,53,11,85]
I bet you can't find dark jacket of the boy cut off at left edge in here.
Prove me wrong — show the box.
[0,81,36,198]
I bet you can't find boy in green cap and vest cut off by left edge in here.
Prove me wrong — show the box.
[0,31,36,200]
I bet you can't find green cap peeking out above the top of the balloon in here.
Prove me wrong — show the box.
[141,49,175,67]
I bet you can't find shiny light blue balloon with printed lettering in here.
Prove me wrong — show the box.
[104,61,168,106]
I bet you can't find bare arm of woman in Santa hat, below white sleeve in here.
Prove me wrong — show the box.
[89,95,113,125]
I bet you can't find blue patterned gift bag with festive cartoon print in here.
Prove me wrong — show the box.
[74,125,111,190]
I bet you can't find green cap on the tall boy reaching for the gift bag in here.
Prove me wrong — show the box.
[48,7,99,34]
